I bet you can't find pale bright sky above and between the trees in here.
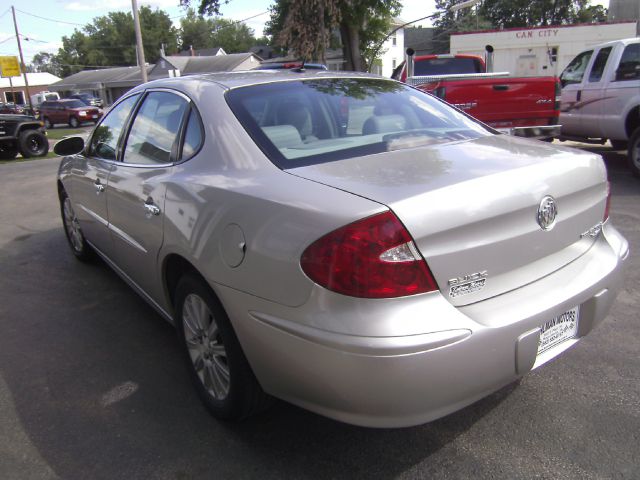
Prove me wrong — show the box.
[0,0,609,67]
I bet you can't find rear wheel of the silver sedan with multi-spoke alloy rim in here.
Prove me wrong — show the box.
[175,275,270,420]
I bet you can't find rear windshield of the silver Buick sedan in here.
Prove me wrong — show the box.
[227,78,491,169]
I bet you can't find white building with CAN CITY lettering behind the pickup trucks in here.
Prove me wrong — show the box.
[450,21,639,76]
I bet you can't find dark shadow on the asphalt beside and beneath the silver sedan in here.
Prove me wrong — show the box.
[0,228,516,479]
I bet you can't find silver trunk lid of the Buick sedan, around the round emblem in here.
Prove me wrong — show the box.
[288,135,607,305]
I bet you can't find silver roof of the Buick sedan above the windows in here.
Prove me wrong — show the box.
[132,69,393,91]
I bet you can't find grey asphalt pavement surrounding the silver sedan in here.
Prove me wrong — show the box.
[0,147,640,480]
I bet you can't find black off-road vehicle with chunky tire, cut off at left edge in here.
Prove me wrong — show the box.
[0,114,49,160]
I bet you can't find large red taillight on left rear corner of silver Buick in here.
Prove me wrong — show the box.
[300,211,438,298]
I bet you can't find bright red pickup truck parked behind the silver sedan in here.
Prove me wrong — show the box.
[395,49,561,138]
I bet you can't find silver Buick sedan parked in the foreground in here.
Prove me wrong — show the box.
[56,71,629,427]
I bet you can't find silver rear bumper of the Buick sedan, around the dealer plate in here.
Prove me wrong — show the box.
[218,225,629,427]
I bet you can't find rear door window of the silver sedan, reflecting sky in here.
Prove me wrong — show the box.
[123,92,188,165]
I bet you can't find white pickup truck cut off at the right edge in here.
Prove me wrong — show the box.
[560,37,640,177]
